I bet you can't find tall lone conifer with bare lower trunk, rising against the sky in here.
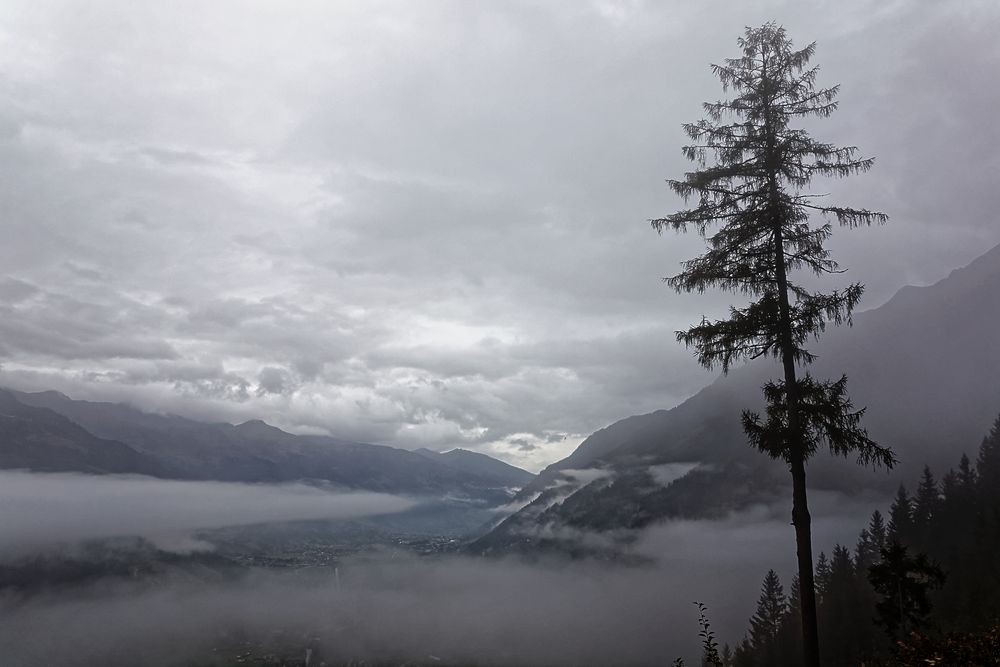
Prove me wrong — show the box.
[651,23,894,667]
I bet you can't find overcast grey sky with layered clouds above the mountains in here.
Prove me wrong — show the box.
[0,0,1000,469]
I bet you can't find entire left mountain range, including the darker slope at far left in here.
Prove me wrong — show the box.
[0,391,528,506]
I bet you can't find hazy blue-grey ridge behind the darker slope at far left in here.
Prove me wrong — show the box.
[11,391,510,504]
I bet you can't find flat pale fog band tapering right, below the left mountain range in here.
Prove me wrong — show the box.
[0,470,413,557]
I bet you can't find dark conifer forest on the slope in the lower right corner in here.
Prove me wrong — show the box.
[722,417,1000,667]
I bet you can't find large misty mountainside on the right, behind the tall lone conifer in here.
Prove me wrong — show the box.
[478,246,1000,551]
